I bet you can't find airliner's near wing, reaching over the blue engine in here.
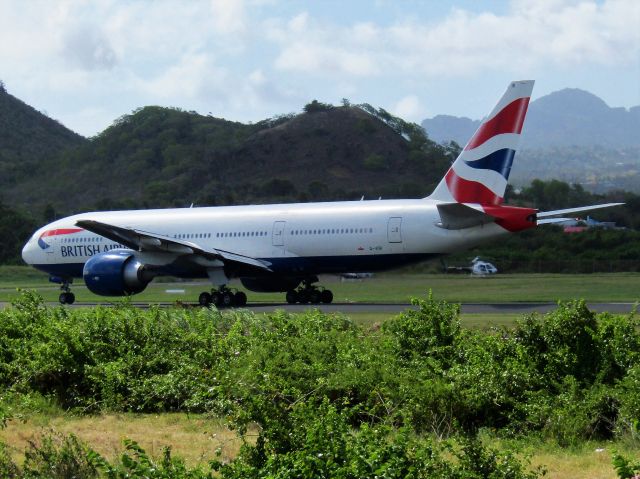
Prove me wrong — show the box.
[76,220,271,272]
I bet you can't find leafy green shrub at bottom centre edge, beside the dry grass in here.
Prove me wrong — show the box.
[212,400,540,479]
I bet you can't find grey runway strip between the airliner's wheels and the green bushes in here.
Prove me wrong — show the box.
[0,302,636,314]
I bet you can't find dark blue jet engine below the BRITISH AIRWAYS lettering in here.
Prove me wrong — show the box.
[82,250,152,296]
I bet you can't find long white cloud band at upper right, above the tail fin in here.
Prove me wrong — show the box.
[270,0,640,76]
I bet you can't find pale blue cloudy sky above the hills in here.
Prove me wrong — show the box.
[0,0,640,136]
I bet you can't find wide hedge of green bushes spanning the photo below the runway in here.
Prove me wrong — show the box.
[0,293,640,445]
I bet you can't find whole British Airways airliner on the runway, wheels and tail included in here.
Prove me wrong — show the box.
[22,80,621,307]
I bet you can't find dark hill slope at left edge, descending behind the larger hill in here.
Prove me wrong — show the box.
[0,82,87,196]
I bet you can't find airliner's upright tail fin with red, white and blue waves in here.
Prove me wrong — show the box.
[428,80,534,205]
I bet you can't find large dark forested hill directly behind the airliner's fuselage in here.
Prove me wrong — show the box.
[4,101,456,214]
